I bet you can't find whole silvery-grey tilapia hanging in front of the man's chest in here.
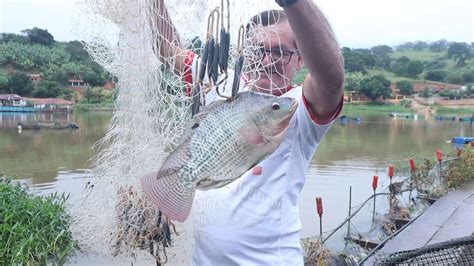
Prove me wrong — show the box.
[140,91,298,222]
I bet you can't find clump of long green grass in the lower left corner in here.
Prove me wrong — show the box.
[0,180,77,265]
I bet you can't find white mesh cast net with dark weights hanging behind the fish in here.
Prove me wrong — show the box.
[73,0,291,263]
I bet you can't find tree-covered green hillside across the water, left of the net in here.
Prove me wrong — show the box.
[0,28,109,98]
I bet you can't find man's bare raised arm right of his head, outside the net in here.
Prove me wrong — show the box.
[284,0,344,121]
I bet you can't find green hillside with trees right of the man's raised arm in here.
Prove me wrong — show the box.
[342,40,474,101]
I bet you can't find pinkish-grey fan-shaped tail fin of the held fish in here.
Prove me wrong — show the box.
[140,169,196,222]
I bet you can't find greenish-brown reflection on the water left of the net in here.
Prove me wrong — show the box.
[0,113,112,184]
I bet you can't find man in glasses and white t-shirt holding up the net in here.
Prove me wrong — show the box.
[157,0,344,265]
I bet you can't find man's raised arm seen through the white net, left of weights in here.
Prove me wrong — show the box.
[152,0,188,75]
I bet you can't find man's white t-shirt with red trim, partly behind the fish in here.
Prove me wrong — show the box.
[182,52,342,265]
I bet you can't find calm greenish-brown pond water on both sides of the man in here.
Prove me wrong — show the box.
[0,112,473,262]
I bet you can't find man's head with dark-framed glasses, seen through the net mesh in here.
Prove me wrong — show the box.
[245,10,303,95]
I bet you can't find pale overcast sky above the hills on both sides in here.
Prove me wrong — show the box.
[0,0,474,48]
